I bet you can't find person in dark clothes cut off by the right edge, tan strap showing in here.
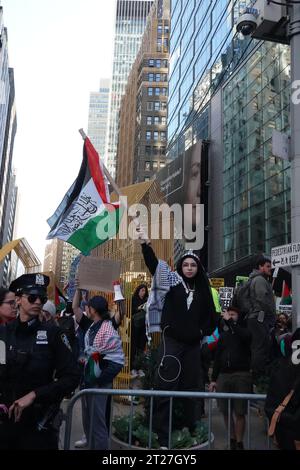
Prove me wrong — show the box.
[265,328,300,450]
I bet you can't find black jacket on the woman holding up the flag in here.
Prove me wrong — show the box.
[142,243,217,344]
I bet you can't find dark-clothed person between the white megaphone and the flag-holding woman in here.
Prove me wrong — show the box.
[130,284,148,377]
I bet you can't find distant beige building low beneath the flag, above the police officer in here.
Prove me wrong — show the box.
[43,238,79,290]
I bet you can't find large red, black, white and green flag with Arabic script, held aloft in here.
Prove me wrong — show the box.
[47,138,121,255]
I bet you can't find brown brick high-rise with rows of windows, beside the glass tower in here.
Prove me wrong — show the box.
[116,0,170,186]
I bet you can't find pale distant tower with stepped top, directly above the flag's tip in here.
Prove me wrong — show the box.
[88,78,110,159]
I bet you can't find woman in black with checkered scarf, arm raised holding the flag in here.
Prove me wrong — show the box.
[138,229,217,448]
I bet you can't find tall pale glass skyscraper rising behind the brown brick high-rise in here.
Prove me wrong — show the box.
[105,0,153,176]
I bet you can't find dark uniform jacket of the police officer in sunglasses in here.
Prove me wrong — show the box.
[0,319,80,420]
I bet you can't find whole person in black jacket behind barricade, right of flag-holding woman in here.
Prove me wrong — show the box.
[209,307,252,450]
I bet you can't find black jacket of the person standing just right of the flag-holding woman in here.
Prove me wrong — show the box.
[212,320,251,382]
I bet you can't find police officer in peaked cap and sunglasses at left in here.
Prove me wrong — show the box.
[0,274,80,450]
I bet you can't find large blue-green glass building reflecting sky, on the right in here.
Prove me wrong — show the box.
[168,0,290,271]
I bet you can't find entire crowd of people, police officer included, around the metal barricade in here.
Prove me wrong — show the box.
[0,244,300,450]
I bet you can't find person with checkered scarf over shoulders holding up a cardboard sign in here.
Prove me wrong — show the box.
[73,289,125,450]
